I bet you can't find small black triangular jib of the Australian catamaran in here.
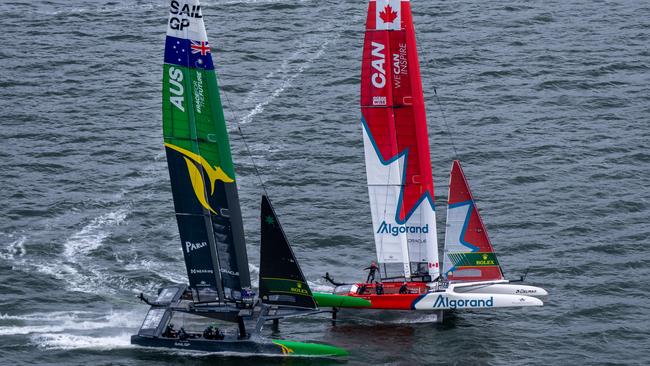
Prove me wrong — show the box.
[260,196,317,309]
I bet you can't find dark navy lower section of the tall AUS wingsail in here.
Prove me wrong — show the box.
[166,147,250,300]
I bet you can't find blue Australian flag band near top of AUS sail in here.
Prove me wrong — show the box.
[165,36,214,70]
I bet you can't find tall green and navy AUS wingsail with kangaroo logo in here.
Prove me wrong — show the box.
[163,0,250,301]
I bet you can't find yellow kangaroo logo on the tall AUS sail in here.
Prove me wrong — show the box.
[165,143,234,215]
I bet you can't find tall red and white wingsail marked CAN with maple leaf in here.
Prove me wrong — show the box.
[361,0,439,279]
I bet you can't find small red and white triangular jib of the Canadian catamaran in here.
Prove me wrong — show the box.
[443,160,503,282]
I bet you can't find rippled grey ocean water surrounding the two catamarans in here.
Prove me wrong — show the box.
[0,0,650,365]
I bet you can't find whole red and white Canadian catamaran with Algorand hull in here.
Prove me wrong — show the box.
[315,0,547,311]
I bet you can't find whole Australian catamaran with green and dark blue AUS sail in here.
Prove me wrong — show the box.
[131,0,347,356]
